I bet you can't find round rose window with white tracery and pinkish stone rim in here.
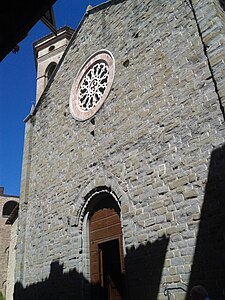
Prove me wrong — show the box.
[70,50,115,121]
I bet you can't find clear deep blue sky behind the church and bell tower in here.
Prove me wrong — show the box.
[0,0,105,195]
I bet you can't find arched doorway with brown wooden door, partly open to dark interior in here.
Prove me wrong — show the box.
[89,192,125,300]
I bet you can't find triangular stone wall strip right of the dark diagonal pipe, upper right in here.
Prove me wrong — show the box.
[190,0,225,116]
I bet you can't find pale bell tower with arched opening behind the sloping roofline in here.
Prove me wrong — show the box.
[33,26,74,103]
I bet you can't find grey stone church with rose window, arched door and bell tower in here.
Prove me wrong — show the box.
[14,0,225,300]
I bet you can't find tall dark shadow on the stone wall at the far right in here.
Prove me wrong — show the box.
[189,146,225,300]
